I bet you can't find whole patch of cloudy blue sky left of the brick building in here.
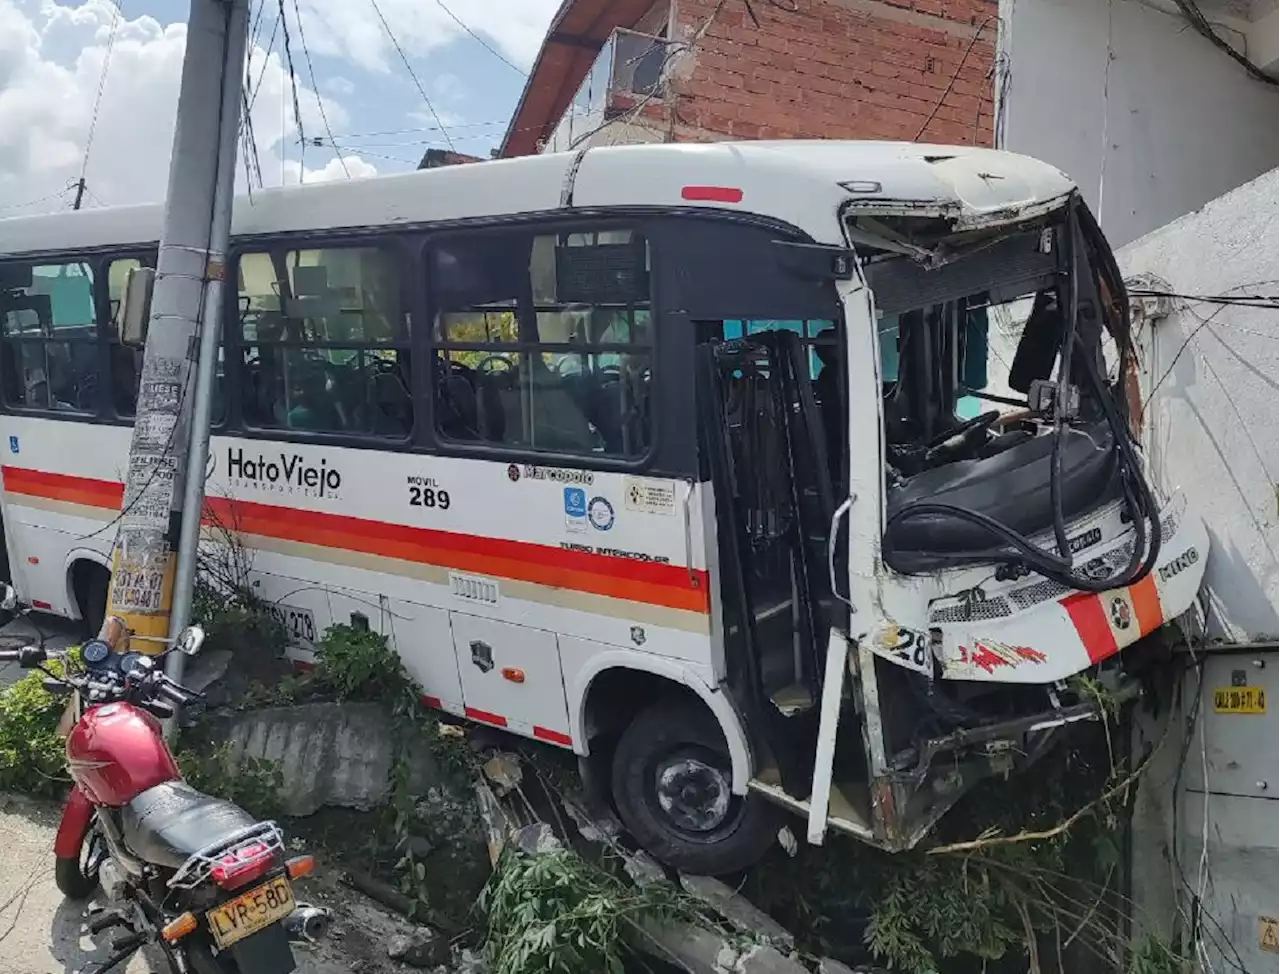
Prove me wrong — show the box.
[0,0,558,216]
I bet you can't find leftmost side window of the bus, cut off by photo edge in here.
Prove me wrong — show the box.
[0,261,97,412]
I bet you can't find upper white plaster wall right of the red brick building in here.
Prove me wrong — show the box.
[1000,0,1280,246]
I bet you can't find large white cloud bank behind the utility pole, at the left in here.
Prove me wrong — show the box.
[0,0,374,216]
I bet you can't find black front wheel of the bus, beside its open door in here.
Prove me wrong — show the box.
[612,700,781,875]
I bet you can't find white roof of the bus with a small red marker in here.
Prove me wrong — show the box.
[0,140,1075,256]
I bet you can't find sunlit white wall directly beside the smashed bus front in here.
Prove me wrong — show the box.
[1119,163,1280,640]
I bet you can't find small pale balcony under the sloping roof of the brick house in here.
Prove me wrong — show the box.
[543,27,671,152]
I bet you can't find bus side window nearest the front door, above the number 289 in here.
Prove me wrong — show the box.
[430,230,654,458]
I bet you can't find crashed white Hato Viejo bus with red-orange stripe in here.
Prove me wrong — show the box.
[0,142,1207,873]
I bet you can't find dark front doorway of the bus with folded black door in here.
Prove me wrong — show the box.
[663,219,860,799]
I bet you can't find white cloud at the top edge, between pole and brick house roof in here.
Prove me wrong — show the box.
[301,0,561,72]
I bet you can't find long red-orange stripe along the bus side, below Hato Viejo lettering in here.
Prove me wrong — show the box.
[0,467,710,614]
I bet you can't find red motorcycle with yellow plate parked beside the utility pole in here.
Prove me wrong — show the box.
[0,604,328,974]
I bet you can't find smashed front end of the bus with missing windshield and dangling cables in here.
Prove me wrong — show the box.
[783,154,1207,849]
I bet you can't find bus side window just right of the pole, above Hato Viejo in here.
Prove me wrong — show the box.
[237,247,413,439]
